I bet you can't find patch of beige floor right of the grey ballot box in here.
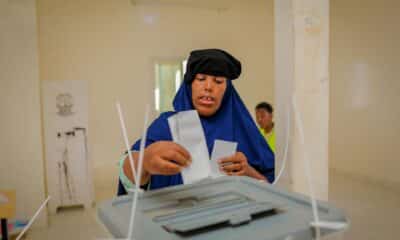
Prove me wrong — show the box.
[329,172,400,240]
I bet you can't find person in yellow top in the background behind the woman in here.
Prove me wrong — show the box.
[255,102,275,153]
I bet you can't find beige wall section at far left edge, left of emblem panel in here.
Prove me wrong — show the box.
[0,0,46,225]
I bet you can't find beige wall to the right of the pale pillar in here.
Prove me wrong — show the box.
[330,0,400,186]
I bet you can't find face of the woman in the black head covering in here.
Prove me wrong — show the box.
[192,73,227,117]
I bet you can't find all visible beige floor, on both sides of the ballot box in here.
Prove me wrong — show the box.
[26,172,400,240]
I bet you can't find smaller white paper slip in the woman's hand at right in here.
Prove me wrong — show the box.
[210,139,237,178]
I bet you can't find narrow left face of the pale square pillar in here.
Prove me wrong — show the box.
[274,0,294,189]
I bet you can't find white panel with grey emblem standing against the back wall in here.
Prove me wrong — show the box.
[42,80,93,213]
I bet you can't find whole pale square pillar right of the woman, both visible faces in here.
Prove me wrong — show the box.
[275,0,329,200]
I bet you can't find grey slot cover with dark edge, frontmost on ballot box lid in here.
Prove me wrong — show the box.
[162,202,280,235]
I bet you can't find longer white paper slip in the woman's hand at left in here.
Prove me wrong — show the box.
[168,110,211,184]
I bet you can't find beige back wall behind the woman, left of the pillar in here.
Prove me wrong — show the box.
[38,0,274,197]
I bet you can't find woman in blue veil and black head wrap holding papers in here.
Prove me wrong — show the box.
[119,49,274,195]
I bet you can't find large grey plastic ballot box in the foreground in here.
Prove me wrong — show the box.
[98,176,347,240]
